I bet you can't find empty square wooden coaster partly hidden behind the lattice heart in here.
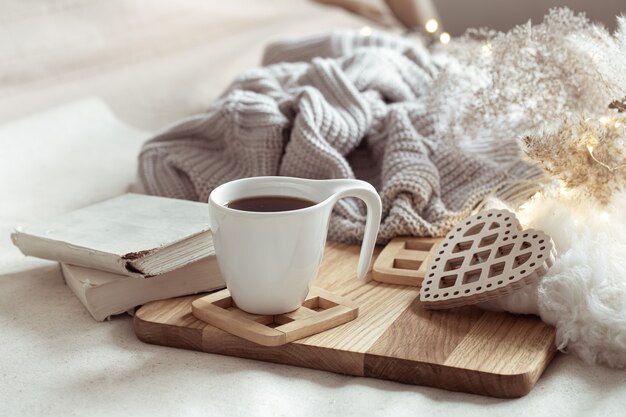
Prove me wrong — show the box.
[372,237,441,287]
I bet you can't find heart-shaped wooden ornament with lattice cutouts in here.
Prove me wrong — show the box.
[420,210,556,309]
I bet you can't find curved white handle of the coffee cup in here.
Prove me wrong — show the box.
[328,179,382,279]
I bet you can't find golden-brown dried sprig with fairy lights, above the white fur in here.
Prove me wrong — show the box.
[523,113,626,204]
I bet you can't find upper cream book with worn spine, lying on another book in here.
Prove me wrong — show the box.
[11,193,215,277]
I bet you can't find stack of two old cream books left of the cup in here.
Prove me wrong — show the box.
[11,194,224,321]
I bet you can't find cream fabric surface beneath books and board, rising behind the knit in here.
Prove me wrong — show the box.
[0,0,626,417]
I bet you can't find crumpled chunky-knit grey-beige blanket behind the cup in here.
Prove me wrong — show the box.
[139,32,536,243]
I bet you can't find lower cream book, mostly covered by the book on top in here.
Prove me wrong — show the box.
[61,256,224,321]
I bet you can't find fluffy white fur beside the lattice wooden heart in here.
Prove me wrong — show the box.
[485,191,626,368]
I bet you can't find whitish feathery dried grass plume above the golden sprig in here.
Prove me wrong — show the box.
[430,8,626,148]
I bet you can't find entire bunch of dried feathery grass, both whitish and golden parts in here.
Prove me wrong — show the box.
[420,8,626,206]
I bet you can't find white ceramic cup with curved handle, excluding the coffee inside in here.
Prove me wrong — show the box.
[209,177,381,315]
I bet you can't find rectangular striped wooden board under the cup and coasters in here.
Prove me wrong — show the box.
[134,243,555,398]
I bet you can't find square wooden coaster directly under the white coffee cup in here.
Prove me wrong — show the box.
[191,288,359,346]
